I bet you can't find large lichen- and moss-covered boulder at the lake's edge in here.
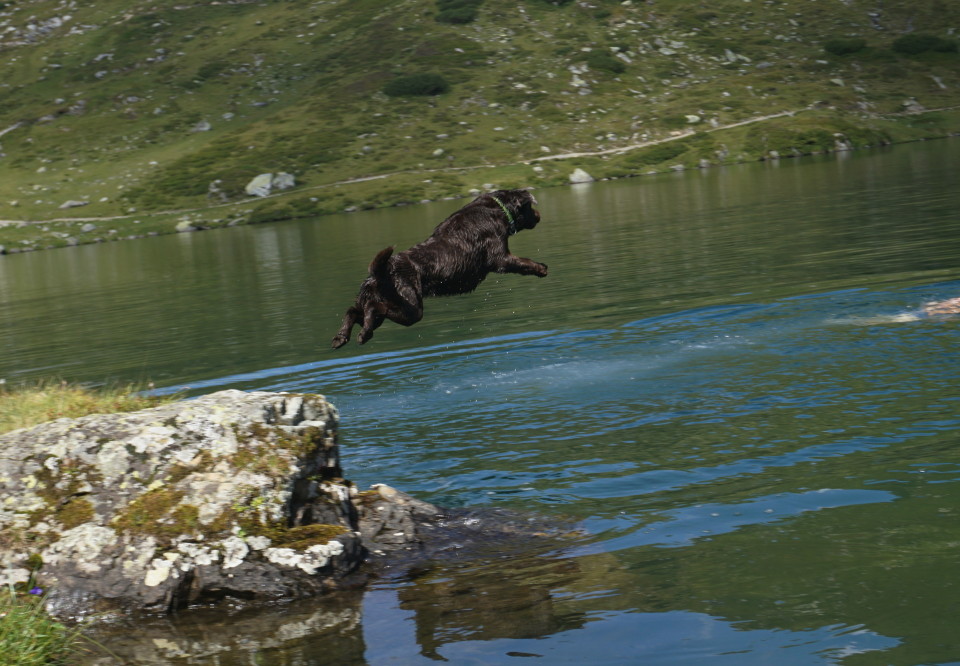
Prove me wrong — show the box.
[0,391,440,617]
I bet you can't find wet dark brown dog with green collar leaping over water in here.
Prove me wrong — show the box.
[332,190,547,349]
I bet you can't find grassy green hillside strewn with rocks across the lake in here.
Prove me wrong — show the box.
[0,0,960,251]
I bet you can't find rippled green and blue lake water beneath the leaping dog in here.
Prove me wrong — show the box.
[0,139,960,665]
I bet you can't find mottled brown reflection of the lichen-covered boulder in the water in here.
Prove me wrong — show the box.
[80,553,585,665]
